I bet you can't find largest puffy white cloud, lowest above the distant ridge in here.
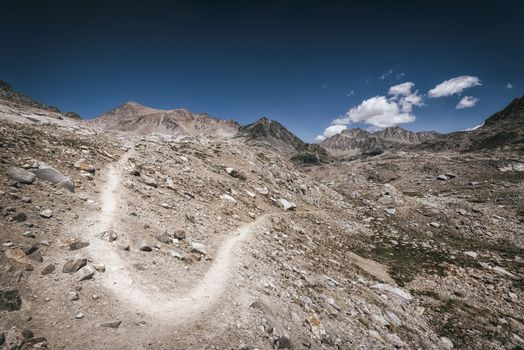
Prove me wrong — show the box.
[332,96,415,128]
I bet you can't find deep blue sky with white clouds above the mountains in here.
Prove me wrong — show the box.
[0,0,524,142]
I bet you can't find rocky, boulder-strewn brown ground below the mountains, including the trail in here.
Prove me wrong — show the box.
[0,110,524,349]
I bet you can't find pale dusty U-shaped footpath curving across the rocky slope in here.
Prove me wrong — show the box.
[88,151,267,324]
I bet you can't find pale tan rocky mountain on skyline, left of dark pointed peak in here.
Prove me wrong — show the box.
[91,102,239,137]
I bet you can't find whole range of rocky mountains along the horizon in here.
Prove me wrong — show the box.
[0,81,524,157]
